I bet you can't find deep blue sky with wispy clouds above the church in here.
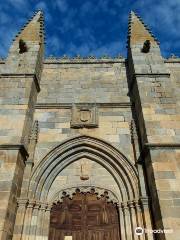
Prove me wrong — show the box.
[0,0,180,57]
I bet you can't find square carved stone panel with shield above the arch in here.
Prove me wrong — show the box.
[71,104,98,128]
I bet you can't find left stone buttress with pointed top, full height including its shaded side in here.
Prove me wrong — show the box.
[0,11,44,239]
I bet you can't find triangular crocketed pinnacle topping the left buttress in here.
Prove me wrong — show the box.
[14,10,44,43]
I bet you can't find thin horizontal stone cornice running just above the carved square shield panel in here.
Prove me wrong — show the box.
[36,102,132,109]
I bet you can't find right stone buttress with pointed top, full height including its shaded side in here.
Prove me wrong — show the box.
[128,12,180,240]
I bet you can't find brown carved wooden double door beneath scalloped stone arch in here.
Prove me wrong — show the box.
[49,189,120,240]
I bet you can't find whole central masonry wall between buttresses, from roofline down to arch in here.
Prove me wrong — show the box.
[34,60,134,167]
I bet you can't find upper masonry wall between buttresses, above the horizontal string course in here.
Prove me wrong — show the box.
[38,60,129,103]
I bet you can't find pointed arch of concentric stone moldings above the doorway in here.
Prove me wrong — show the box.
[29,135,139,202]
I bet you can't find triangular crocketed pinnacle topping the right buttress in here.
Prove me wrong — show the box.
[128,11,159,45]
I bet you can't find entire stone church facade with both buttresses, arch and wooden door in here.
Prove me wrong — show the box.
[0,11,180,240]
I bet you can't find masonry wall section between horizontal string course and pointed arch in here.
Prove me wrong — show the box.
[34,108,134,165]
